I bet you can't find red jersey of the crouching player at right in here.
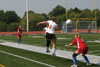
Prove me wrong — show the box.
[72,37,88,49]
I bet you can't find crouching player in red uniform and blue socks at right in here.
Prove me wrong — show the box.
[65,33,91,67]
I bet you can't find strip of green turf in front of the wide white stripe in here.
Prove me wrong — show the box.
[0,45,99,67]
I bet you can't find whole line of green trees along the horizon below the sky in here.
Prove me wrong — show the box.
[0,5,100,32]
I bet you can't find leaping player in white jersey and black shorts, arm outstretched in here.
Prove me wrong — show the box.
[37,16,58,55]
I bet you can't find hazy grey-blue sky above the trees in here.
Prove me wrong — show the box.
[0,0,100,17]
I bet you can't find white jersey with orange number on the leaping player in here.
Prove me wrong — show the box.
[47,20,58,34]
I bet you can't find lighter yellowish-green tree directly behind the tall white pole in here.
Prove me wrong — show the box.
[20,11,46,31]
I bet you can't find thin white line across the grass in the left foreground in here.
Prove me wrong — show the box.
[0,50,55,67]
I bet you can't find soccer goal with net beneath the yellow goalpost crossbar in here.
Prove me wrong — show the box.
[62,21,97,33]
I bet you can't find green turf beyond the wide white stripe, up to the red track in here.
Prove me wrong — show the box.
[0,34,100,56]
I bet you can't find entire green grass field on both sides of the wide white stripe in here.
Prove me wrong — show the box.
[0,34,100,67]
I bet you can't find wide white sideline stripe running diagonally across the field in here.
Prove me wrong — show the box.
[0,42,100,65]
